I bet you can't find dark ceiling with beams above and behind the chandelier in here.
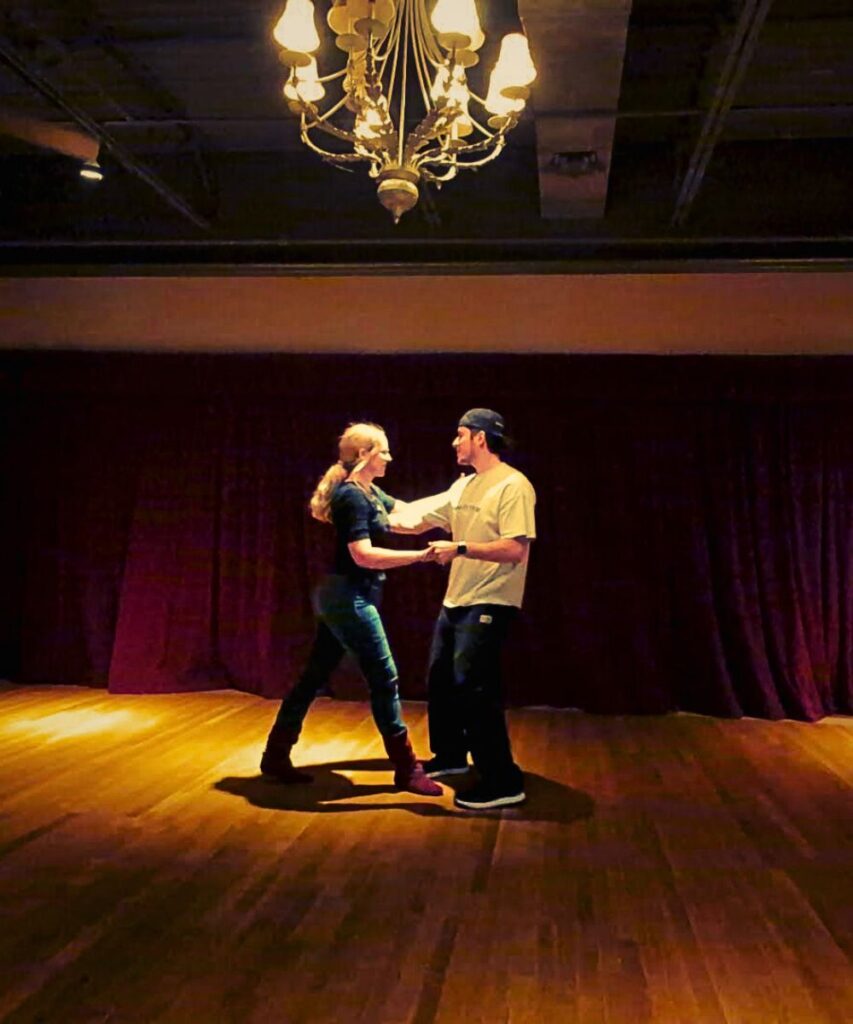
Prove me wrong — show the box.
[0,0,853,273]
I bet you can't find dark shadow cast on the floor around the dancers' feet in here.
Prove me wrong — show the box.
[213,759,595,824]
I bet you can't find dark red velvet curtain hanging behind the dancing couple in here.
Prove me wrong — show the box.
[0,352,853,720]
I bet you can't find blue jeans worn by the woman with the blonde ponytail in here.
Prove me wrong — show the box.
[275,575,406,737]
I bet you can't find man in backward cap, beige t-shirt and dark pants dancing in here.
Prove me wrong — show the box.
[391,409,536,809]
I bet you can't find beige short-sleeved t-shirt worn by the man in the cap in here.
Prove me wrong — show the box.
[424,462,536,608]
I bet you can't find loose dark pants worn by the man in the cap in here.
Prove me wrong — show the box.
[428,604,522,787]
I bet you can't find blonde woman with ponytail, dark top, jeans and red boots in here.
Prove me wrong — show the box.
[261,423,441,797]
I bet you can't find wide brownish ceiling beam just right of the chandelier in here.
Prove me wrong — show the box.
[518,0,631,219]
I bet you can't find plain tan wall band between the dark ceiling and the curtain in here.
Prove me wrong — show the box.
[0,271,853,354]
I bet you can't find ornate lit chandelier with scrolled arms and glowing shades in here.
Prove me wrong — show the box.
[272,0,536,223]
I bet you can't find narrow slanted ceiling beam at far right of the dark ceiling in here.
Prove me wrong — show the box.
[672,0,773,226]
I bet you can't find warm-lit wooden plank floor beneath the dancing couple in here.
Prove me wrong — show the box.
[0,686,853,1024]
